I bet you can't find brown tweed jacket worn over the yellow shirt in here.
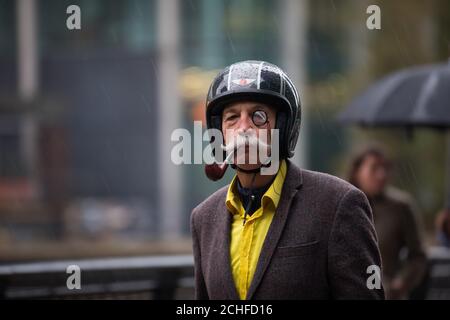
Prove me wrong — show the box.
[191,161,384,300]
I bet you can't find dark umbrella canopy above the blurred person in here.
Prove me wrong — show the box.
[339,60,450,129]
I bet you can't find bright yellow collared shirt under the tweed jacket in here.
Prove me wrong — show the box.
[226,160,287,300]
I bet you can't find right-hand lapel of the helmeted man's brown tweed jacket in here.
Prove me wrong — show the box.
[244,161,303,300]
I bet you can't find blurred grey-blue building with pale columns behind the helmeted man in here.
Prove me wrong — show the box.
[0,0,307,260]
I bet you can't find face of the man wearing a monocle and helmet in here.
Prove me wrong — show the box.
[222,102,276,170]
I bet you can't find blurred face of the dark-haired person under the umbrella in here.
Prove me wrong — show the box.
[356,155,388,196]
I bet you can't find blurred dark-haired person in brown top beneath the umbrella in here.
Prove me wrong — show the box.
[349,146,426,299]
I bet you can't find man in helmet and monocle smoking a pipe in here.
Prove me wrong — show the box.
[191,61,384,299]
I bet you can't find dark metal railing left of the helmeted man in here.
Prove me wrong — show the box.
[0,255,194,299]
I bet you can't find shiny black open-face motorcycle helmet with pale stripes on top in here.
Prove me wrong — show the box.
[206,60,301,159]
